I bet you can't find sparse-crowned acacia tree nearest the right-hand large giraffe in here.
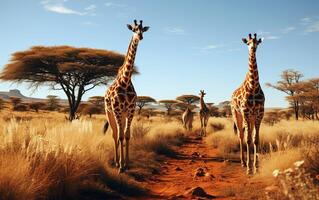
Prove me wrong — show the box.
[266,69,303,120]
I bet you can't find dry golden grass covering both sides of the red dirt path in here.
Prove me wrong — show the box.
[0,106,319,199]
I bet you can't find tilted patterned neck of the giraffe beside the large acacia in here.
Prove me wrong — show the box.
[117,36,139,85]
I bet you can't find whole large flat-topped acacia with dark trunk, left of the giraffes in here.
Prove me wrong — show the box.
[0,46,133,120]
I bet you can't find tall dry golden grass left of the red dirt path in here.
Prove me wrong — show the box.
[0,112,188,200]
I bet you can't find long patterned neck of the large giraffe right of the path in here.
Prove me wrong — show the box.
[244,49,259,90]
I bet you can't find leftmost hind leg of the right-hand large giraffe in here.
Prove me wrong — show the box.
[233,111,246,167]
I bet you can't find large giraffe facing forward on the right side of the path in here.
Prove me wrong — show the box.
[231,33,265,174]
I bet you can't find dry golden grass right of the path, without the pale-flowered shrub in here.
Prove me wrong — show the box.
[206,119,319,176]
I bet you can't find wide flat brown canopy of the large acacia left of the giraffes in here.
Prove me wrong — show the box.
[0,46,137,84]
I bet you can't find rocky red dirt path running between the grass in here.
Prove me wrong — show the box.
[143,132,265,199]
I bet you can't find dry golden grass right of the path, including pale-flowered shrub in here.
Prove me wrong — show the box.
[206,115,319,199]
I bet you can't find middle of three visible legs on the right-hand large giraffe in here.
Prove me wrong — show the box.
[244,114,254,174]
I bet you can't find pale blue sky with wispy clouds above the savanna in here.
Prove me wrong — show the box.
[0,0,319,107]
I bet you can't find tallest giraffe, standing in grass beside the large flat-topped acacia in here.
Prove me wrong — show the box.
[104,20,149,173]
